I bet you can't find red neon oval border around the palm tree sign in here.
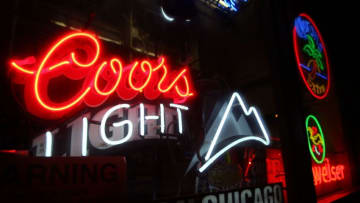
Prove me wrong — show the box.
[293,13,330,99]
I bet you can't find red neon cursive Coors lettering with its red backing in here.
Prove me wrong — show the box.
[10,32,194,119]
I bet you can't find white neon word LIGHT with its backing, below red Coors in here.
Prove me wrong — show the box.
[33,103,189,157]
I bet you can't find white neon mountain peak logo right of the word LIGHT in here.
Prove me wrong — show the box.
[187,92,270,172]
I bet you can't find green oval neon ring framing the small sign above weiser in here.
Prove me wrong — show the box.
[305,115,326,164]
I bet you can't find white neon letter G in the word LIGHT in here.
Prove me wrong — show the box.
[100,104,133,145]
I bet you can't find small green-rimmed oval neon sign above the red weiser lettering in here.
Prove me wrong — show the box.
[305,115,325,164]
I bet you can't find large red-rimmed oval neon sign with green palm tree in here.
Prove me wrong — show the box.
[293,13,330,99]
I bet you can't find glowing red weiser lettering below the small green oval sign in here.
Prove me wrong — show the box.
[312,158,345,186]
